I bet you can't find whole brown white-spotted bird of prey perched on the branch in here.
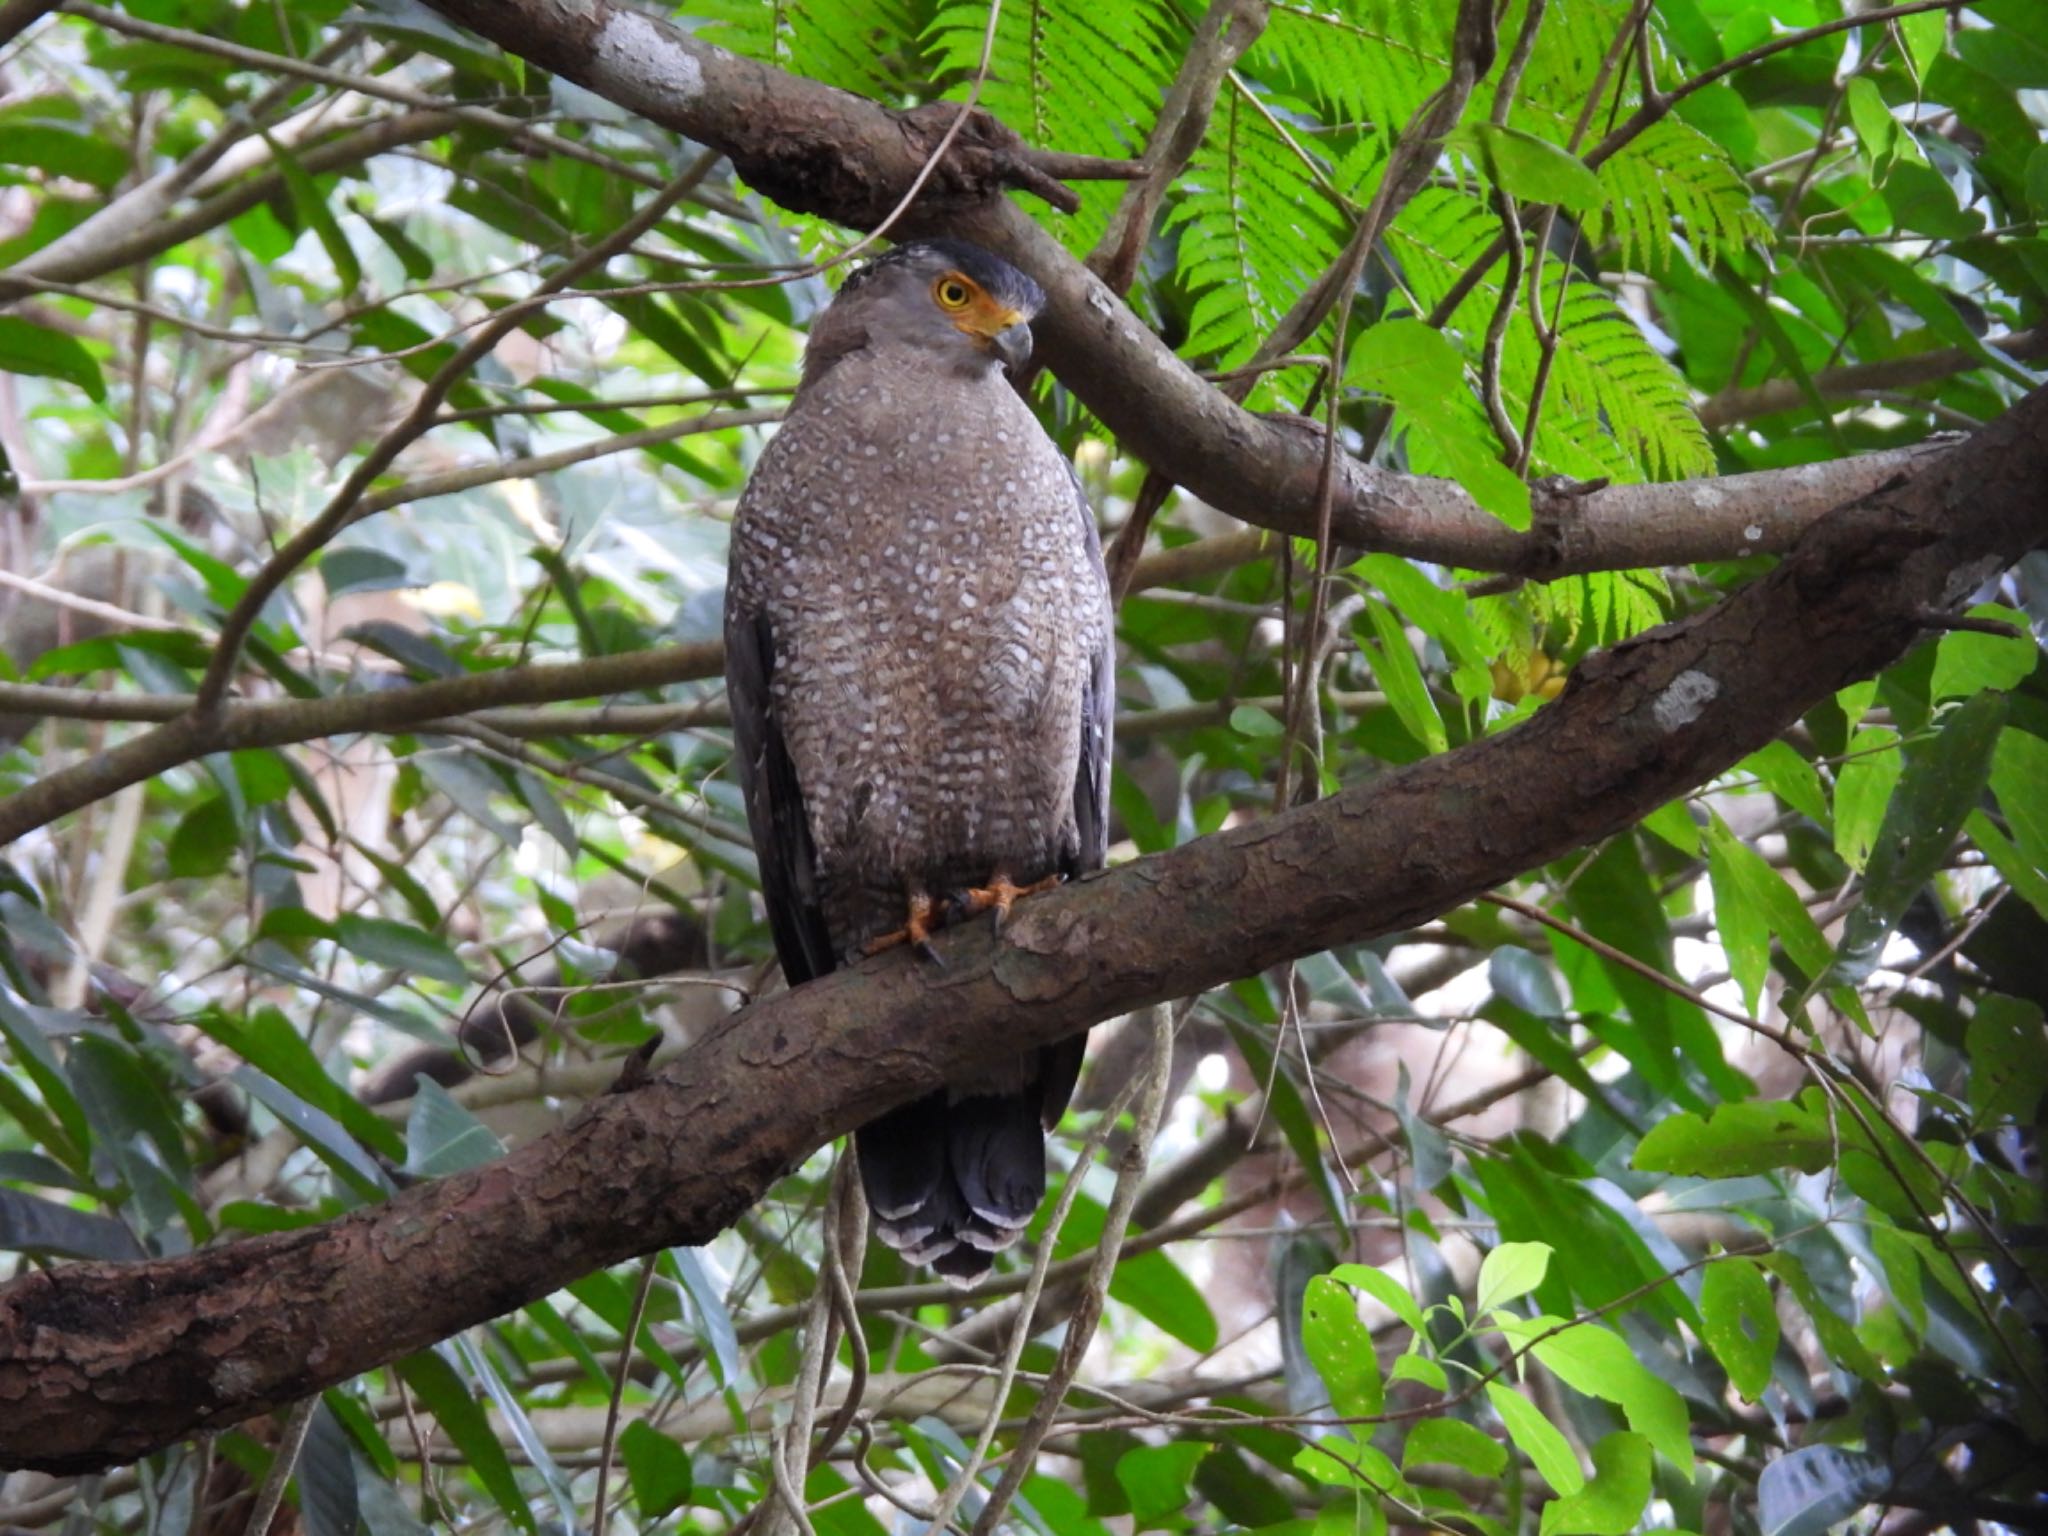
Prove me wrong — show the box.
[725,240,1114,1284]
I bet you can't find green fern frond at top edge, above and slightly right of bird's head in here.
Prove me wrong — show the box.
[926,0,1188,250]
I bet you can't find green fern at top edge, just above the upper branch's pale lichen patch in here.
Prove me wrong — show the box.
[688,0,918,98]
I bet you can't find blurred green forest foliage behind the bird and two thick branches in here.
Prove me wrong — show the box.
[0,0,2048,1536]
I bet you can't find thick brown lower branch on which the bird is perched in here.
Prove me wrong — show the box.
[0,389,2048,1470]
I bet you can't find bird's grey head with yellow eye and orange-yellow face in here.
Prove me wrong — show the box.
[805,240,1044,385]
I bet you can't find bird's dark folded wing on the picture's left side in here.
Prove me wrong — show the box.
[725,604,838,987]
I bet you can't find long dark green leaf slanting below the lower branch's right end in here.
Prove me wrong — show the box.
[1835,694,2007,983]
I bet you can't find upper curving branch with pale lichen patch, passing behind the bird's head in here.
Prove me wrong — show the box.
[411,0,1948,580]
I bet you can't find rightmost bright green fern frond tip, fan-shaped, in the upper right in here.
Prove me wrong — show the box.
[1587,117,1772,272]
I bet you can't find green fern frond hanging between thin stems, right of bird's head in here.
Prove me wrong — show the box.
[1167,90,1346,382]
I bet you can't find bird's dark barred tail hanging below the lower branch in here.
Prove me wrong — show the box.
[854,1092,1044,1284]
